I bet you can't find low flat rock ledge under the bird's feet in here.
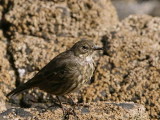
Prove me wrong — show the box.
[0,102,149,120]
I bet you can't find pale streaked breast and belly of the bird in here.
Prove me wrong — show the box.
[48,55,95,95]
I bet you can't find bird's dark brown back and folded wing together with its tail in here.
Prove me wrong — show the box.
[7,52,79,96]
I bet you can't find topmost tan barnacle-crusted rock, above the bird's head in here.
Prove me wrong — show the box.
[5,0,118,39]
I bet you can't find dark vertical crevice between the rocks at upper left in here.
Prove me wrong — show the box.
[0,1,20,86]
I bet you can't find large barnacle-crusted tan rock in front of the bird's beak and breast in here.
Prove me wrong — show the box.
[82,15,160,119]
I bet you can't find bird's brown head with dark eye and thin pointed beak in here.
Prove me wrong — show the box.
[71,40,103,57]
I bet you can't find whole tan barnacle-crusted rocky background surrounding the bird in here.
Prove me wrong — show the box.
[0,0,160,120]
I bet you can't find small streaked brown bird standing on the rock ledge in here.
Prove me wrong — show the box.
[7,40,102,116]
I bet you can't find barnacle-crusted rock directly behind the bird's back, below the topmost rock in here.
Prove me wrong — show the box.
[9,33,102,106]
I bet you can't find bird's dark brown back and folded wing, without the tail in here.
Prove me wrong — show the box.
[33,52,78,82]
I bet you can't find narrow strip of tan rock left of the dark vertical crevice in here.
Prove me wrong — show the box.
[0,30,15,112]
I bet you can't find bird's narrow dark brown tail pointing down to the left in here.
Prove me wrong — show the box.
[6,80,34,97]
